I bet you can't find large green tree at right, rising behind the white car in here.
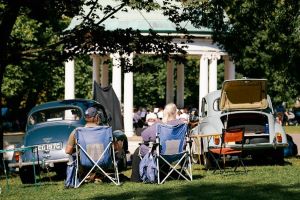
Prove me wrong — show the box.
[183,0,300,103]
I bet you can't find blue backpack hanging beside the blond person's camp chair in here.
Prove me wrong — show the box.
[139,152,157,183]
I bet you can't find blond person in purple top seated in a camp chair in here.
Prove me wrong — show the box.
[131,103,183,182]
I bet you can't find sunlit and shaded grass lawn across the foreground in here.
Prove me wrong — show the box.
[0,158,300,200]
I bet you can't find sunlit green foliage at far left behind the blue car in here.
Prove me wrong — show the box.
[1,12,64,128]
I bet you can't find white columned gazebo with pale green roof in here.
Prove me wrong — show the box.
[65,0,235,137]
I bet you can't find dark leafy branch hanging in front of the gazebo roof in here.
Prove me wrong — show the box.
[62,0,190,68]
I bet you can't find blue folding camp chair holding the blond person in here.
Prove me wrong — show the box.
[156,124,193,184]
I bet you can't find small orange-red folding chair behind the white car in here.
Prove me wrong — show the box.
[208,128,247,172]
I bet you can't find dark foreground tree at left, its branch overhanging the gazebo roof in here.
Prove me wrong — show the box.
[0,0,192,159]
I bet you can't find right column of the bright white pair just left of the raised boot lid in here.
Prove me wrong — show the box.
[208,55,220,92]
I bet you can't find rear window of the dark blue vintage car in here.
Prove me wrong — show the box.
[28,107,82,125]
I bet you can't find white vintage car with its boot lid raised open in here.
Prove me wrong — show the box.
[192,79,288,168]
